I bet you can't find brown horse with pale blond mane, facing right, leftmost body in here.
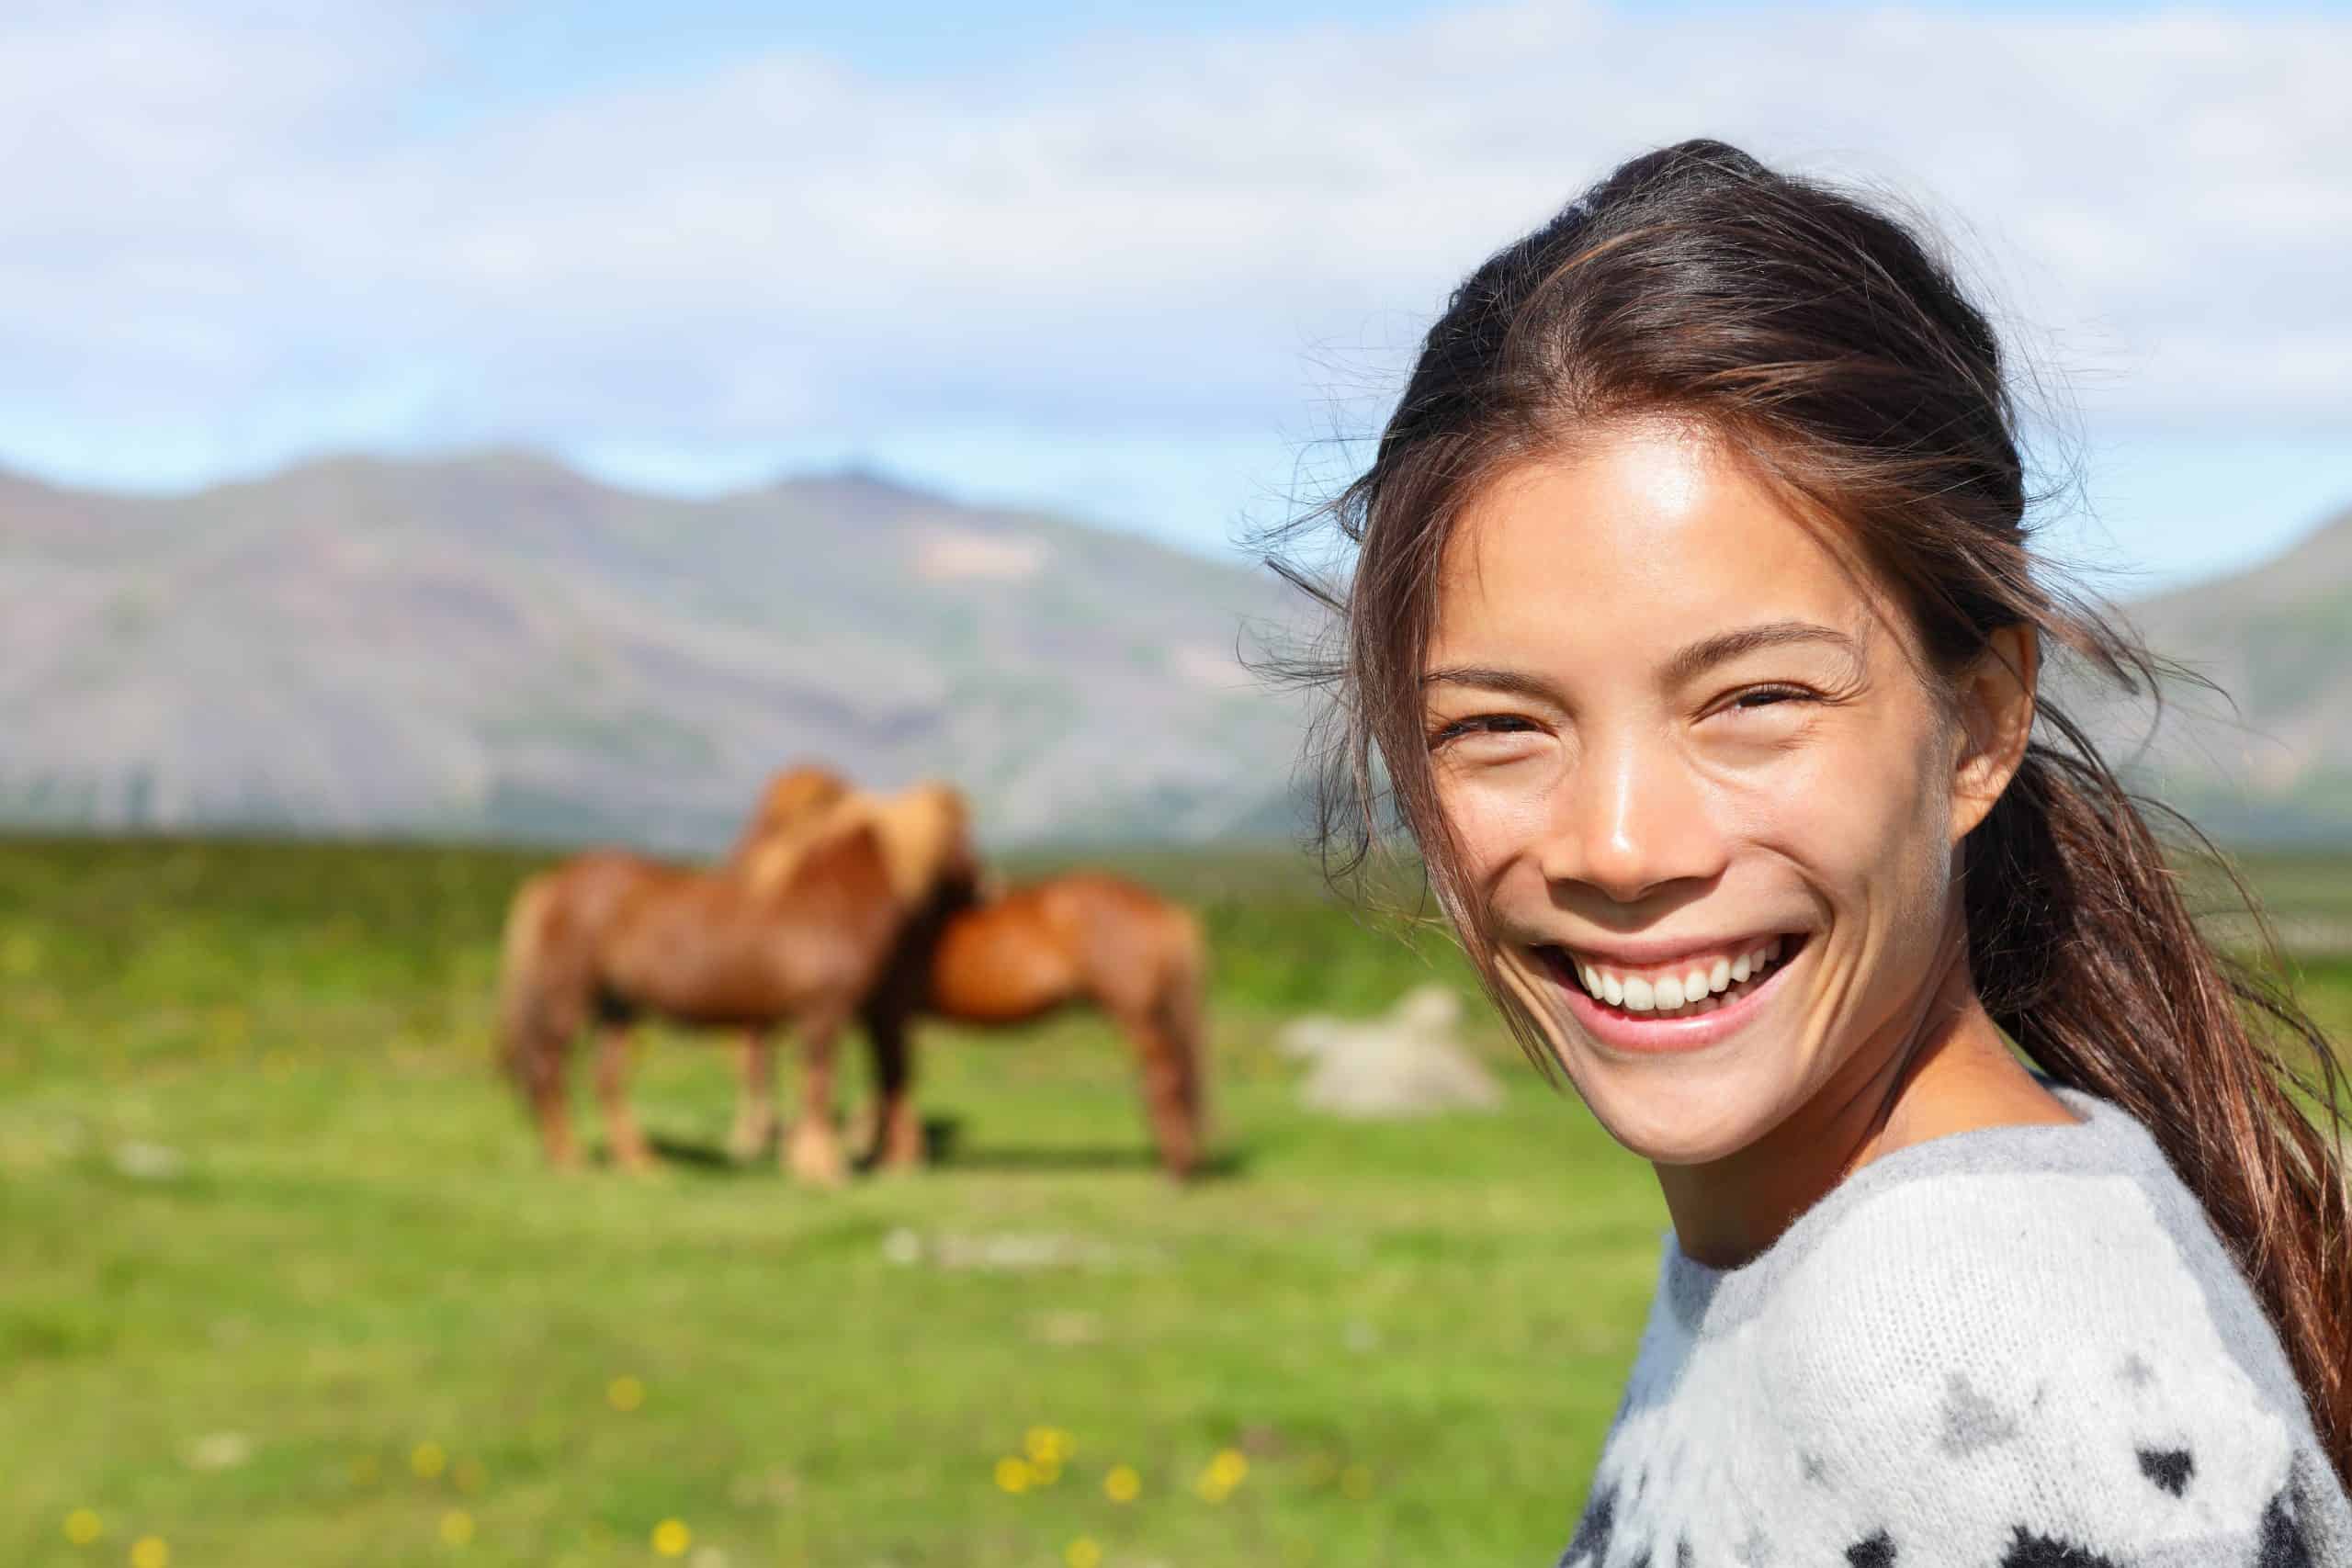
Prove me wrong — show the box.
[501,785,974,1180]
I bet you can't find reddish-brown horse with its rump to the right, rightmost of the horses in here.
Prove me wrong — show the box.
[743,872,1206,1178]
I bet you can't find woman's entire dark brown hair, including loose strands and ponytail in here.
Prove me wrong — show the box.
[1270,141,2352,1481]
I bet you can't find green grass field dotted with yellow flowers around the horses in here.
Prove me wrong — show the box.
[0,841,2352,1568]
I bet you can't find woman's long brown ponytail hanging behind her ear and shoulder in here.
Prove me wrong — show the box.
[1962,707,2352,1483]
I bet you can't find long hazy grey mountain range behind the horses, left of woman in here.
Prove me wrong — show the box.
[0,454,1326,849]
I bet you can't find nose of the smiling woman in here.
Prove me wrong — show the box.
[1541,739,1724,903]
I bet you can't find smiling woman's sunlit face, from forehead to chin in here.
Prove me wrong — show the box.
[1423,425,1981,1164]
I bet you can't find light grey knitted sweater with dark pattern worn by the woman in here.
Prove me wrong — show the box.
[1559,1089,2352,1568]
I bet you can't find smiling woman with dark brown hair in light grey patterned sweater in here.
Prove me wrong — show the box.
[1291,141,2352,1568]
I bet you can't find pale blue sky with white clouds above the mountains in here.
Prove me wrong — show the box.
[0,0,2352,585]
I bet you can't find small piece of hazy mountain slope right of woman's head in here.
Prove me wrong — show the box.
[2103,510,2352,841]
